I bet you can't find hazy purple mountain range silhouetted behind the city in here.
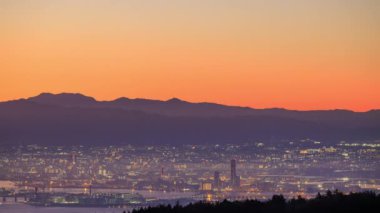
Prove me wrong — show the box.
[0,93,380,145]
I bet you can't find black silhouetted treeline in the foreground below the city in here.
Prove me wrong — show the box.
[132,191,380,213]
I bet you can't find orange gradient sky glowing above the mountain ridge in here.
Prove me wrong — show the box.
[0,0,380,111]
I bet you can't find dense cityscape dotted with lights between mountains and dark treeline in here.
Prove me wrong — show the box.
[0,139,380,207]
